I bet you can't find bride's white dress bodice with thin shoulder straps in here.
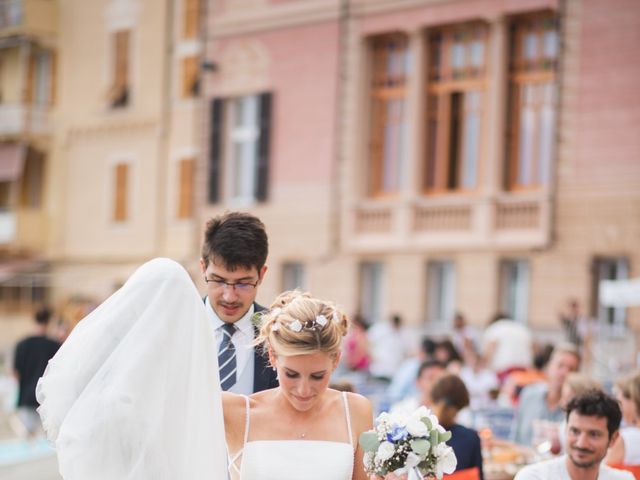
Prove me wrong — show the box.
[229,392,354,480]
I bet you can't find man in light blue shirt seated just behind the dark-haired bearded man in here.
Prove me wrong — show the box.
[514,344,580,446]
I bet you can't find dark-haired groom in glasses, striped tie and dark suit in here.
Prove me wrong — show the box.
[200,212,278,395]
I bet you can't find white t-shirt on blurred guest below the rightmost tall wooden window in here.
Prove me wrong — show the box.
[483,320,533,372]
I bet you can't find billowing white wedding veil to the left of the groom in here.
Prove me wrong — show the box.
[36,258,227,480]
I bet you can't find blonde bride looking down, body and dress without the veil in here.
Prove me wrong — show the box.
[222,291,372,480]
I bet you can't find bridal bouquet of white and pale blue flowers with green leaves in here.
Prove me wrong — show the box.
[360,407,457,480]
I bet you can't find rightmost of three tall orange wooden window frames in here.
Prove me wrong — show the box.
[504,11,559,191]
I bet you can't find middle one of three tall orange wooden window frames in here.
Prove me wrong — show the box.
[423,22,489,195]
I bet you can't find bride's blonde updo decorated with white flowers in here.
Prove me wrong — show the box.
[256,290,349,358]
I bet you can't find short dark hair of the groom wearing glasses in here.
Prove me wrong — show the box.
[202,212,269,272]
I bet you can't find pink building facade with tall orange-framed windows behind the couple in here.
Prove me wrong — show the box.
[202,0,640,352]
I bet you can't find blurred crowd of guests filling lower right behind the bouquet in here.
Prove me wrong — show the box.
[344,308,640,480]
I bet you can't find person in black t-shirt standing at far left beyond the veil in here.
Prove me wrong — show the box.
[13,307,60,437]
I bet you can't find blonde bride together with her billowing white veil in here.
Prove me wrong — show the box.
[36,259,372,480]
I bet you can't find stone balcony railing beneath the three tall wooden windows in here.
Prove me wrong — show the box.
[344,192,550,252]
